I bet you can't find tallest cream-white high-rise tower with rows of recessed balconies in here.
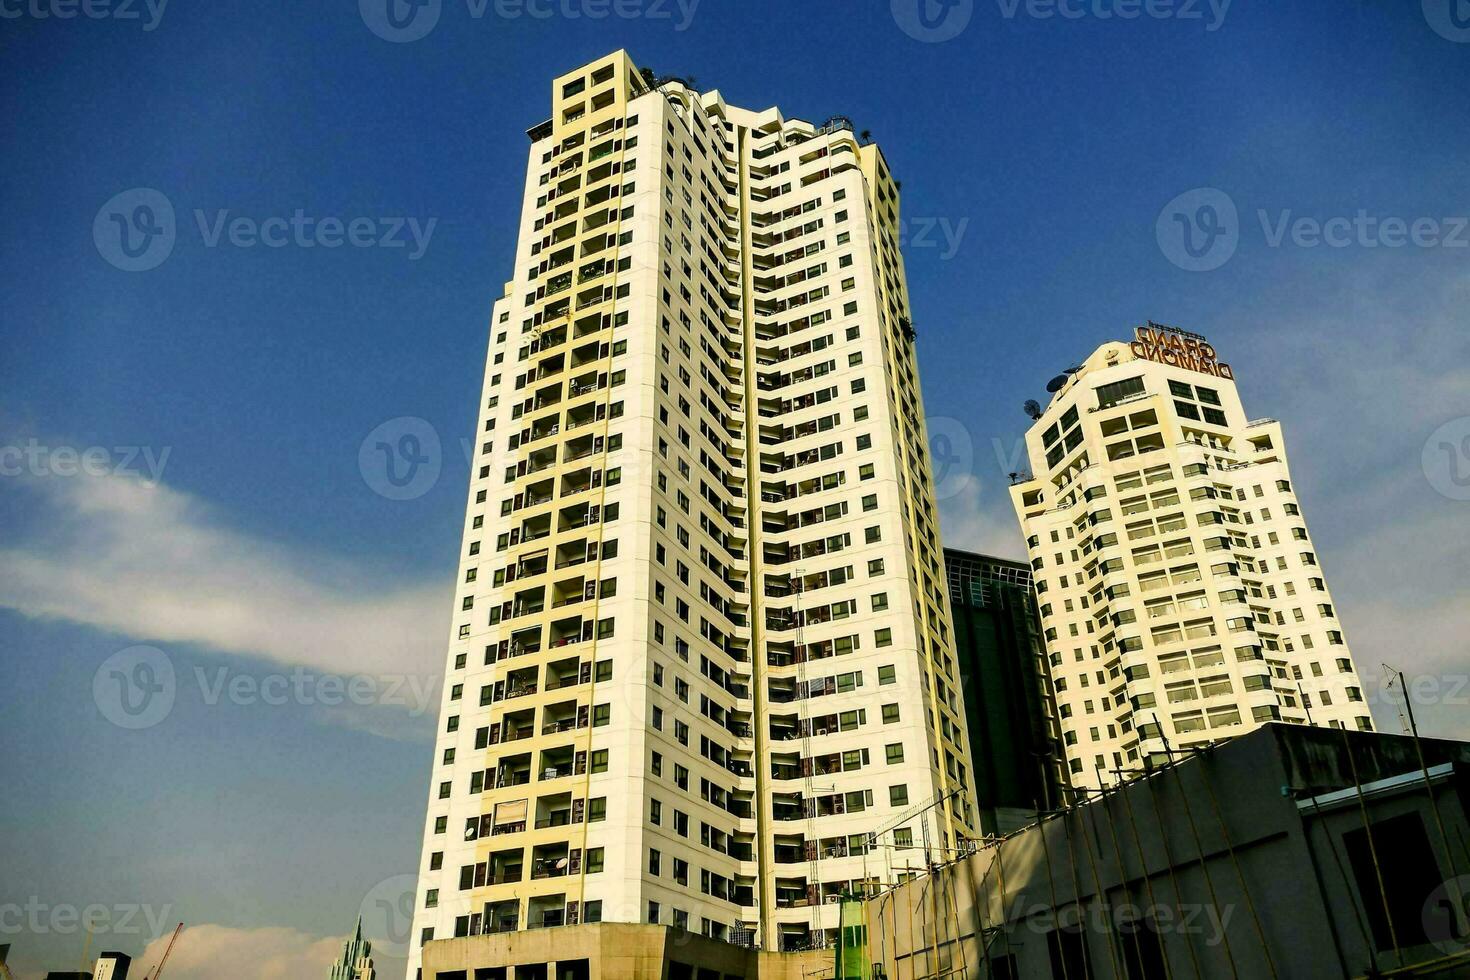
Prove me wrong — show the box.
[410,51,973,976]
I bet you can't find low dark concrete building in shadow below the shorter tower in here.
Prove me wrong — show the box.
[869,726,1470,980]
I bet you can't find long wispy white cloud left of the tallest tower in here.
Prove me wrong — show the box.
[0,475,448,705]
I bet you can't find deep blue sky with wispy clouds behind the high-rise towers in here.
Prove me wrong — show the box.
[0,0,1470,980]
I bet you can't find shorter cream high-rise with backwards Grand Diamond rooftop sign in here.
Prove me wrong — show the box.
[1011,323,1372,788]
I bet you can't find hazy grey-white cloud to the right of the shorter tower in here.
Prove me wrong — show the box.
[1232,264,1470,738]
